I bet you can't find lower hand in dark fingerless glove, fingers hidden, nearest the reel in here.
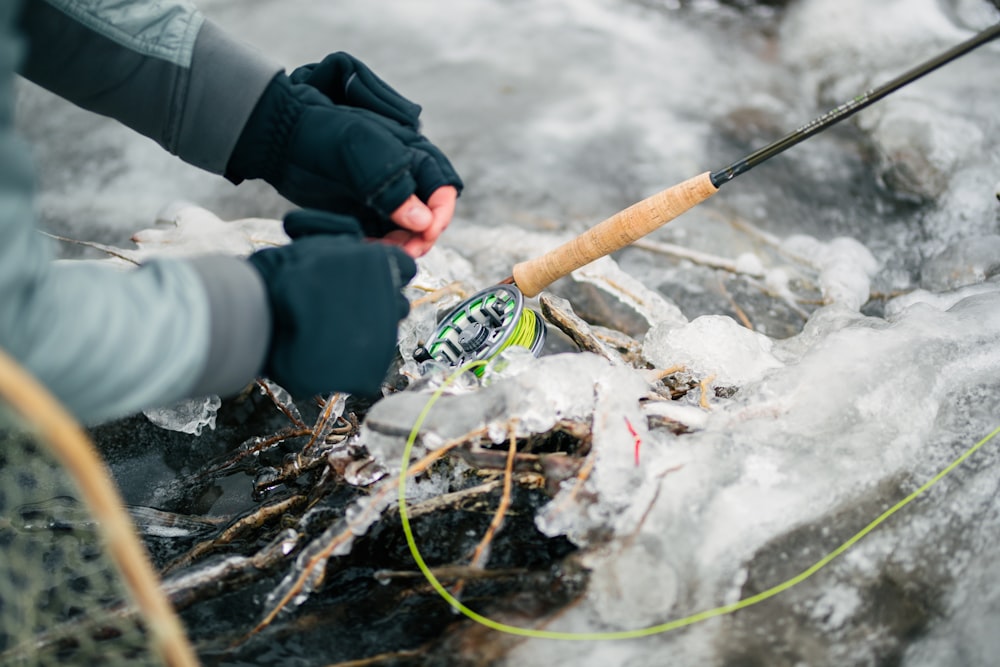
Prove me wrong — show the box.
[248,210,417,398]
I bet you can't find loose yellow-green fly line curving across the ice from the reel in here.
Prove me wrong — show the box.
[398,361,1000,641]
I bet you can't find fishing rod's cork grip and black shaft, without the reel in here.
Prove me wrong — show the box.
[501,23,1000,297]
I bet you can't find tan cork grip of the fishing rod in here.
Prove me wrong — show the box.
[505,171,719,297]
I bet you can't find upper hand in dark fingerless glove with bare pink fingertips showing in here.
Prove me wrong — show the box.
[226,54,462,257]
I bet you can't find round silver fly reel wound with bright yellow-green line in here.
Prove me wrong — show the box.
[413,285,545,375]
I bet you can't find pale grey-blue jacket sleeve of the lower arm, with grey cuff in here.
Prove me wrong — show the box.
[0,0,270,423]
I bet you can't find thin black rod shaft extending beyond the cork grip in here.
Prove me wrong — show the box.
[710,23,1000,188]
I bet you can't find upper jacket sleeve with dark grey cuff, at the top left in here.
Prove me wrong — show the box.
[21,0,281,173]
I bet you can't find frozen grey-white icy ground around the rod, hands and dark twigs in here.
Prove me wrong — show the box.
[13,0,1000,667]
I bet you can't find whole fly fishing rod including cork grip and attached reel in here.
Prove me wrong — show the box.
[414,23,1000,373]
